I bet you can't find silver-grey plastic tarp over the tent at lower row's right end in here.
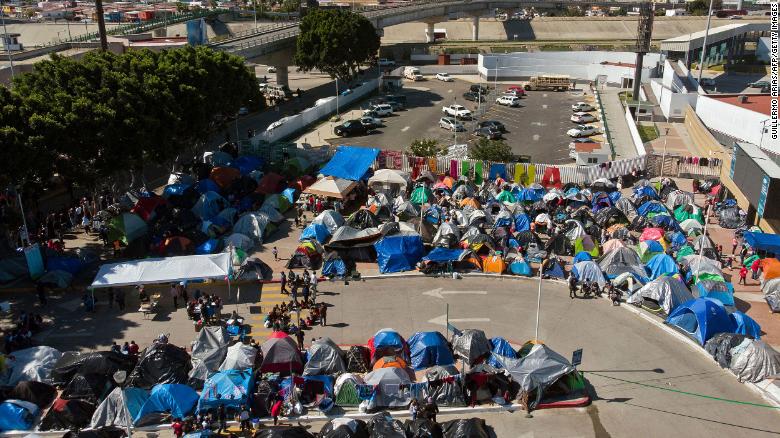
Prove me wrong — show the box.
[498,344,575,406]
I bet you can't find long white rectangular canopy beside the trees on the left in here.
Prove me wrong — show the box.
[92,253,230,288]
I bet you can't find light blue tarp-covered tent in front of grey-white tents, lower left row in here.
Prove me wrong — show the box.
[198,369,253,413]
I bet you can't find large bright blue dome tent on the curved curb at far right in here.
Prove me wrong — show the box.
[666,298,734,345]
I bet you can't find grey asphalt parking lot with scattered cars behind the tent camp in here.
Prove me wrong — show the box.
[329,76,600,163]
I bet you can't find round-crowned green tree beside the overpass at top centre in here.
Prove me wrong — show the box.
[295,9,379,80]
